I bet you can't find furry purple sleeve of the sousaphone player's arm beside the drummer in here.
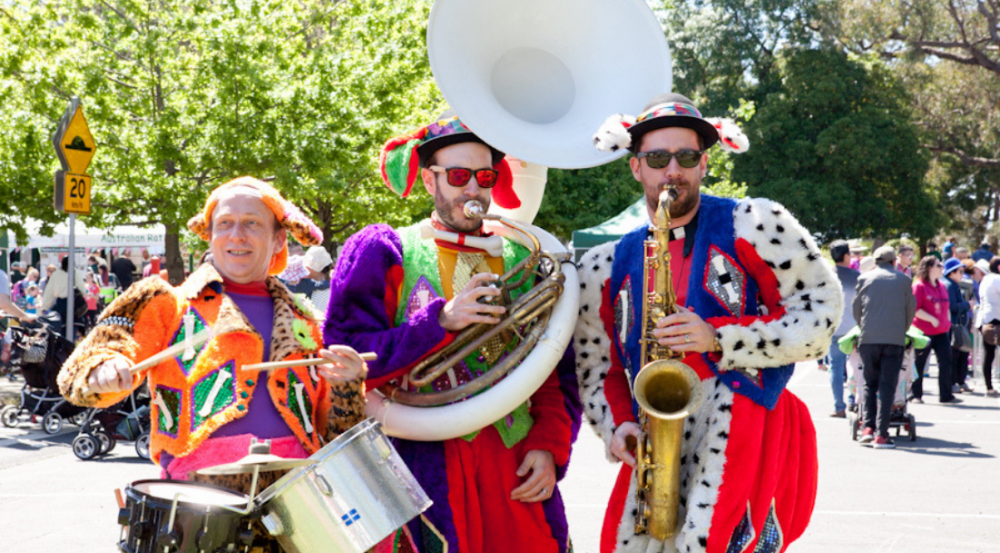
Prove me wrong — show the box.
[323,225,447,380]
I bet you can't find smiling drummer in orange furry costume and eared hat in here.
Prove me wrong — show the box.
[59,177,367,491]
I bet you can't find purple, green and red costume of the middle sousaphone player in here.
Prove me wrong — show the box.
[324,225,580,553]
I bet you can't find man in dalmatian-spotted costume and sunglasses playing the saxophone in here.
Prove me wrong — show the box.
[573,94,843,553]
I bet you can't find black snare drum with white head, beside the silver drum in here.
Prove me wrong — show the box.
[118,480,253,553]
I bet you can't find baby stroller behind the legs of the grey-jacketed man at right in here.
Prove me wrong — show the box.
[838,327,929,442]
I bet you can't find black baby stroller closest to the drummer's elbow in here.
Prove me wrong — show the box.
[73,384,149,461]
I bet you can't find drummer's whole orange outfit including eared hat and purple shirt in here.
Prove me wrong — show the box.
[59,177,364,490]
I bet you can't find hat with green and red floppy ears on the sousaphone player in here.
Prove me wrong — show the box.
[379,110,521,209]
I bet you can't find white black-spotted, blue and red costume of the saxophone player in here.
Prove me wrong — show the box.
[574,194,843,553]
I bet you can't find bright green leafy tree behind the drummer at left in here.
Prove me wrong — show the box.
[0,0,441,281]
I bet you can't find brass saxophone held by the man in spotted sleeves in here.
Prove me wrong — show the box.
[632,186,701,541]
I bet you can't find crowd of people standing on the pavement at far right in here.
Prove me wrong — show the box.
[820,237,1000,449]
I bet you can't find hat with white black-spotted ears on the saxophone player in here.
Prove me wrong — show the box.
[594,93,750,154]
